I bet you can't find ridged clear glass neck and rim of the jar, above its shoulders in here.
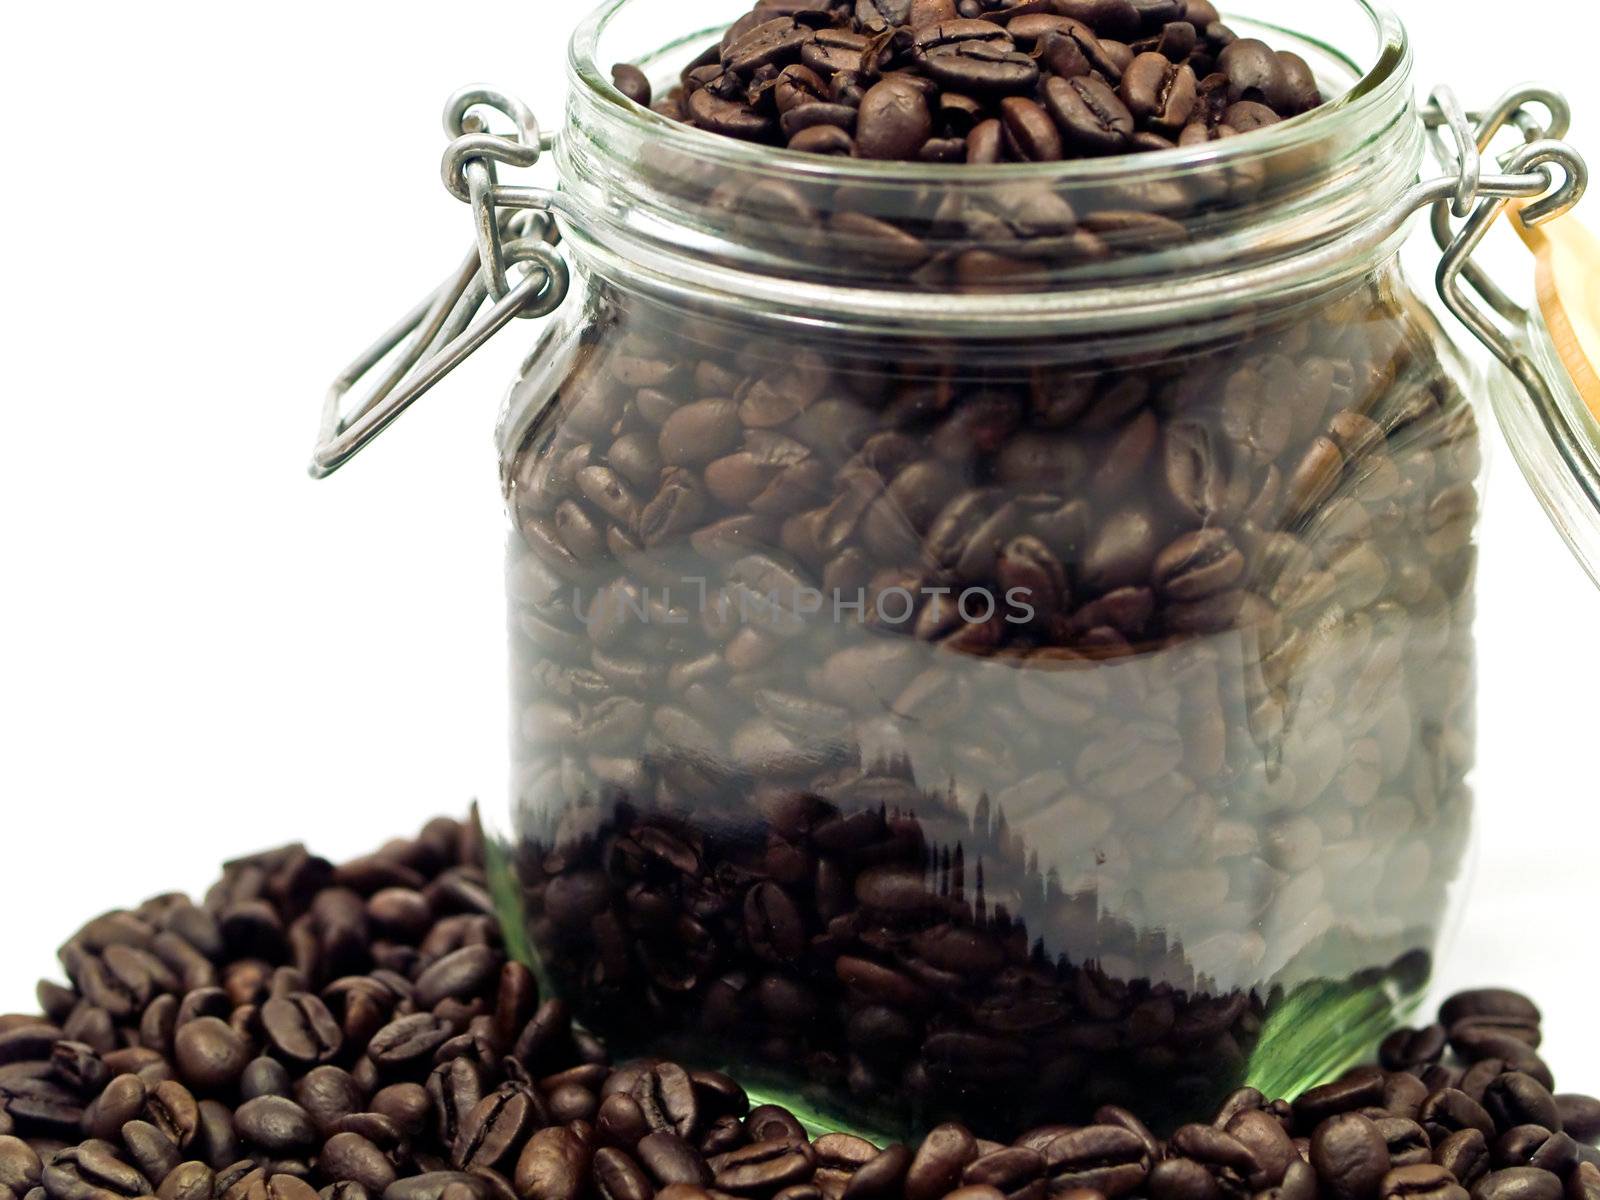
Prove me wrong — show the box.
[555,0,1424,336]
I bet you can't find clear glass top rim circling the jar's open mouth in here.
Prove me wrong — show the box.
[568,0,1411,186]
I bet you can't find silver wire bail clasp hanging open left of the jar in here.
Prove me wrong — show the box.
[310,83,570,478]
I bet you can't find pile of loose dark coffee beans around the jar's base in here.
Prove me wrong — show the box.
[0,819,1600,1200]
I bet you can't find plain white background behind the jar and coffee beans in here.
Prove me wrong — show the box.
[0,0,1600,1090]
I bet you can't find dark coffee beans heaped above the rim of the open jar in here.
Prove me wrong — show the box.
[613,0,1322,163]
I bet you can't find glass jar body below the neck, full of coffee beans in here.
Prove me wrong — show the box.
[502,254,1480,1134]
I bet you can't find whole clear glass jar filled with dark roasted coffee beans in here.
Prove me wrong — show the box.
[308,0,1573,1134]
